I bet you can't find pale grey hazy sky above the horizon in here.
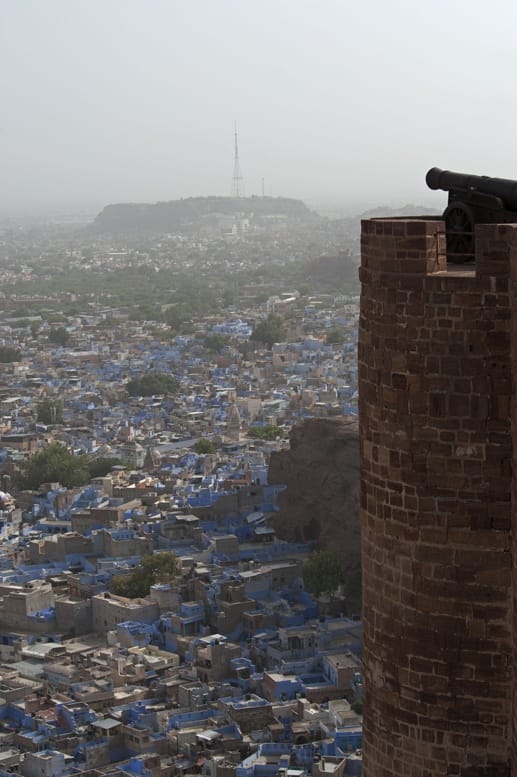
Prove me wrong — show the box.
[0,0,517,213]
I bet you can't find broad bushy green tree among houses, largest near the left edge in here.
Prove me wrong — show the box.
[20,442,90,489]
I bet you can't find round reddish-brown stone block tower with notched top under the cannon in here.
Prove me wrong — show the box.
[359,218,517,777]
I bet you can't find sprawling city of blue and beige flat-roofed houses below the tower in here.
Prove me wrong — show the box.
[0,201,362,777]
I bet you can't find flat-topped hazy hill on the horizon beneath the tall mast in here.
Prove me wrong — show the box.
[92,197,320,233]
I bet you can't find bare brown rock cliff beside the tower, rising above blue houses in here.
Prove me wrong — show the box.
[268,416,361,579]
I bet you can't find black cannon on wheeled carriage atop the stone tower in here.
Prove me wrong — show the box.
[425,167,517,264]
